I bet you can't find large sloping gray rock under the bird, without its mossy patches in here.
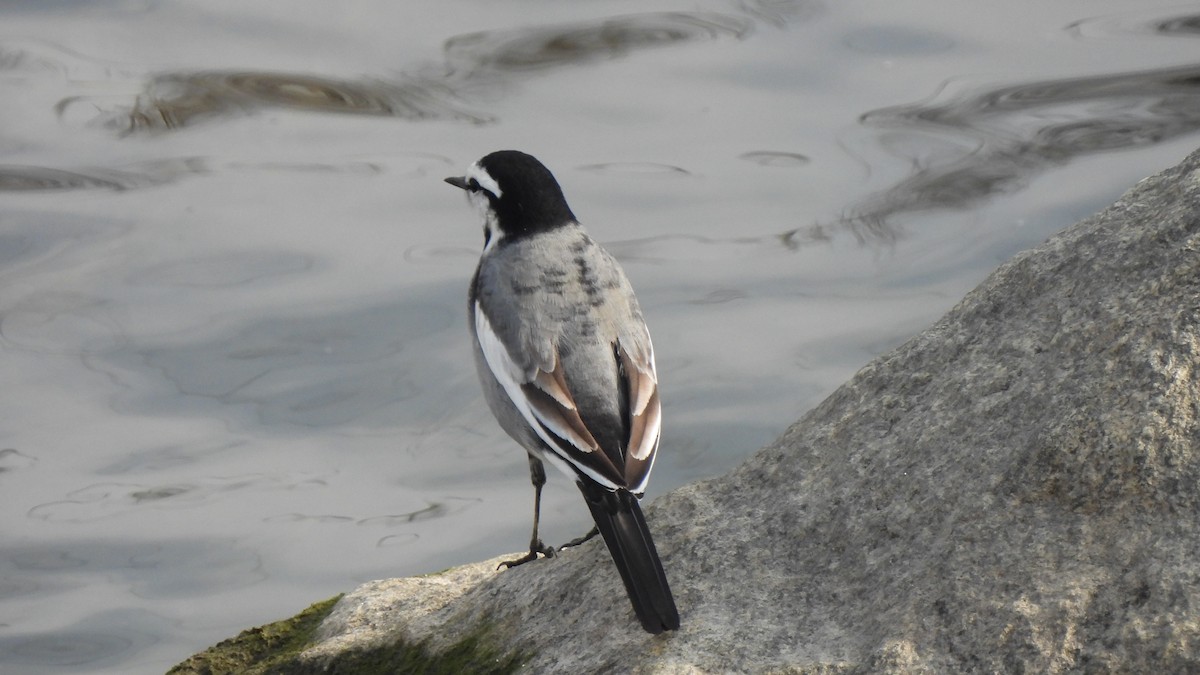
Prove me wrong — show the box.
[297,153,1200,673]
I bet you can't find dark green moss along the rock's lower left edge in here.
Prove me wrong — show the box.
[167,596,528,675]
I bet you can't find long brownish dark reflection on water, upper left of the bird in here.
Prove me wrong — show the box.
[120,71,488,131]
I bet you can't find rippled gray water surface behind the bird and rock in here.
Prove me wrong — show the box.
[0,0,1200,675]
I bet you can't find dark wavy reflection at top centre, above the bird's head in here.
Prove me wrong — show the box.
[445,12,754,71]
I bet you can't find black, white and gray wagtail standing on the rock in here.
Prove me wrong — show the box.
[446,150,679,633]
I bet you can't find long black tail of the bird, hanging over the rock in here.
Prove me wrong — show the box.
[578,483,679,633]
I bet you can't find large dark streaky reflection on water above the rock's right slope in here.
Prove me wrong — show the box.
[851,65,1200,234]
